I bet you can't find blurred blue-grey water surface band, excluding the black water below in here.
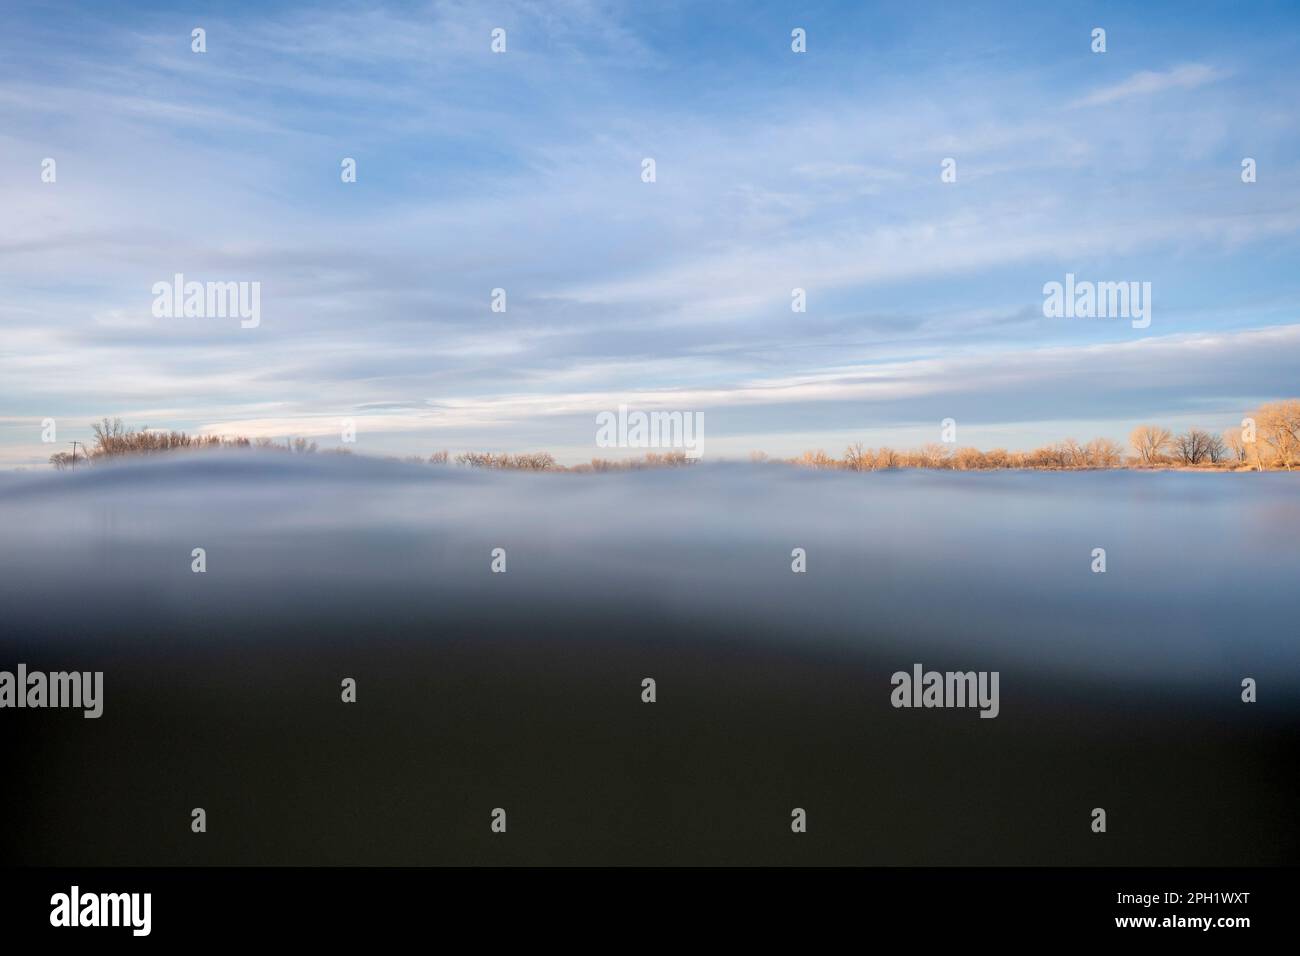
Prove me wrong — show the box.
[0,454,1300,691]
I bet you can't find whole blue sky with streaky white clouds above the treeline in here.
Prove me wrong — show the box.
[0,0,1300,468]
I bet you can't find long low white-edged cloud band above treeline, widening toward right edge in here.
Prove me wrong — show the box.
[180,324,1300,445]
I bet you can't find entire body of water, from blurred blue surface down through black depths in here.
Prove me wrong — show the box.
[0,455,1300,865]
